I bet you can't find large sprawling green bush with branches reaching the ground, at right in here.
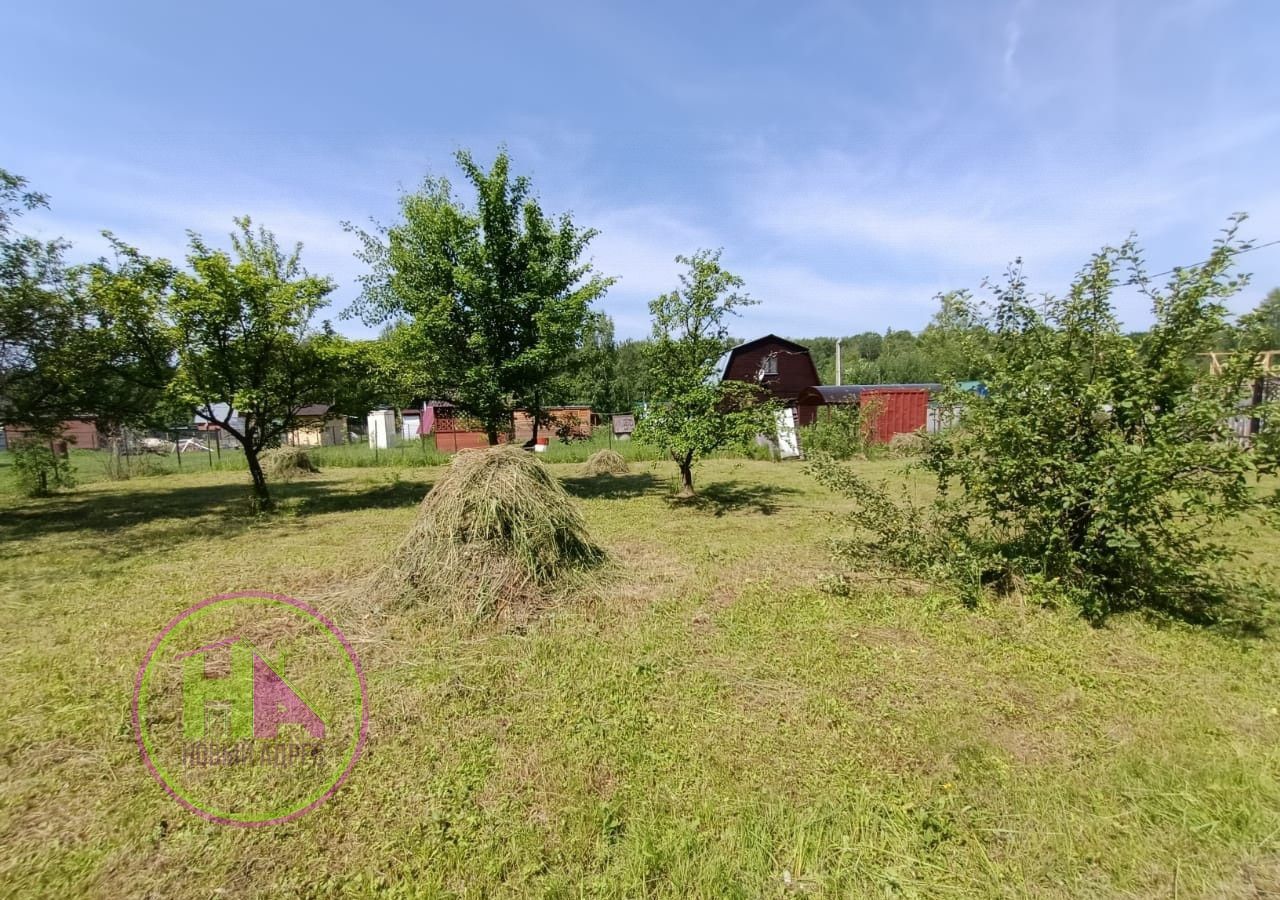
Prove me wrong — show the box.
[815,220,1272,621]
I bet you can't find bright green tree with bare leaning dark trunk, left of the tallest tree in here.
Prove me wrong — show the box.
[166,216,334,508]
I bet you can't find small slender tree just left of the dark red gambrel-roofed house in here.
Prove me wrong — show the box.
[635,250,773,497]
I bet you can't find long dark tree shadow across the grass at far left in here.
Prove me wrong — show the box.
[0,476,430,558]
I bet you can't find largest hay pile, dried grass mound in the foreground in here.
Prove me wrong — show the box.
[389,447,604,622]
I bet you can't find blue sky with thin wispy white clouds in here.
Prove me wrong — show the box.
[0,0,1280,337]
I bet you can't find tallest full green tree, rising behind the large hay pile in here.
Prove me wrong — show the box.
[347,151,612,443]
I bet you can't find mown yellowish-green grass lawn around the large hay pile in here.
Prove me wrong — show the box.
[0,460,1280,897]
